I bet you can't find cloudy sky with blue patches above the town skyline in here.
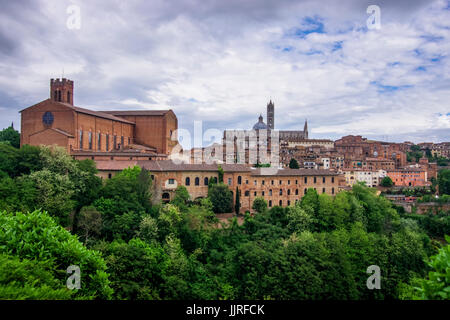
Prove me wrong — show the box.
[0,0,450,147]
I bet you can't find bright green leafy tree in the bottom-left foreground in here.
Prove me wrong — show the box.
[0,211,112,299]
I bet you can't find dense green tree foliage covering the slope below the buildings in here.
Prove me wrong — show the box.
[0,143,450,299]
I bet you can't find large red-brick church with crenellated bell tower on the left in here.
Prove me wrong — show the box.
[20,78,178,160]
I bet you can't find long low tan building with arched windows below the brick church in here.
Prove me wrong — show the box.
[96,160,345,212]
